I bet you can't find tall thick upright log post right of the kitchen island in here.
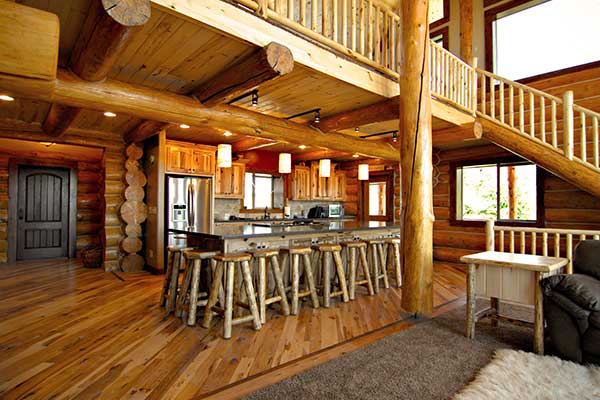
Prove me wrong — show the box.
[399,0,434,315]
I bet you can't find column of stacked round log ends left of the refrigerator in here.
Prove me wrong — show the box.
[121,143,147,272]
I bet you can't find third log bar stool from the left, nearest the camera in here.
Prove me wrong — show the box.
[202,253,261,339]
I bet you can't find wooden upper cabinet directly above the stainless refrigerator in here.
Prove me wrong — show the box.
[166,140,215,175]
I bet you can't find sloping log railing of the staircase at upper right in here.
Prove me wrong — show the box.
[475,68,600,172]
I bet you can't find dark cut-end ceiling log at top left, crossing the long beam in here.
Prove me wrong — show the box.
[42,0,150,137]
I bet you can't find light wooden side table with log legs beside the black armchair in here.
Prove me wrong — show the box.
[460,251,568,354]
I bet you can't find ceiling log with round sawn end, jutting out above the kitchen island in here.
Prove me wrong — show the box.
[193,42,294,107]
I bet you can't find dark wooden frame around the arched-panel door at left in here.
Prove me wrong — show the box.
[8,158,77,263]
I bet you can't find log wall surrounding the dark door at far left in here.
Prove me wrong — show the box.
[0,131,125,271]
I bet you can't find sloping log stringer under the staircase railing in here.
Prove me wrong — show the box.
[476,118,600,197]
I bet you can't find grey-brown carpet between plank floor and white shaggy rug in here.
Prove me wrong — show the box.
[246,307,533,399]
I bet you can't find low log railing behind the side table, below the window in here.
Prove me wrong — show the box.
[485,221,600,274]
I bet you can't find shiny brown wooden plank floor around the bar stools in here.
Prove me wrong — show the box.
[0,260,465,399]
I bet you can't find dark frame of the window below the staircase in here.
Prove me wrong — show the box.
[448,157,546,228]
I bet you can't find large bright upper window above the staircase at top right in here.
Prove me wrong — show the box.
[485,0,600,80]
